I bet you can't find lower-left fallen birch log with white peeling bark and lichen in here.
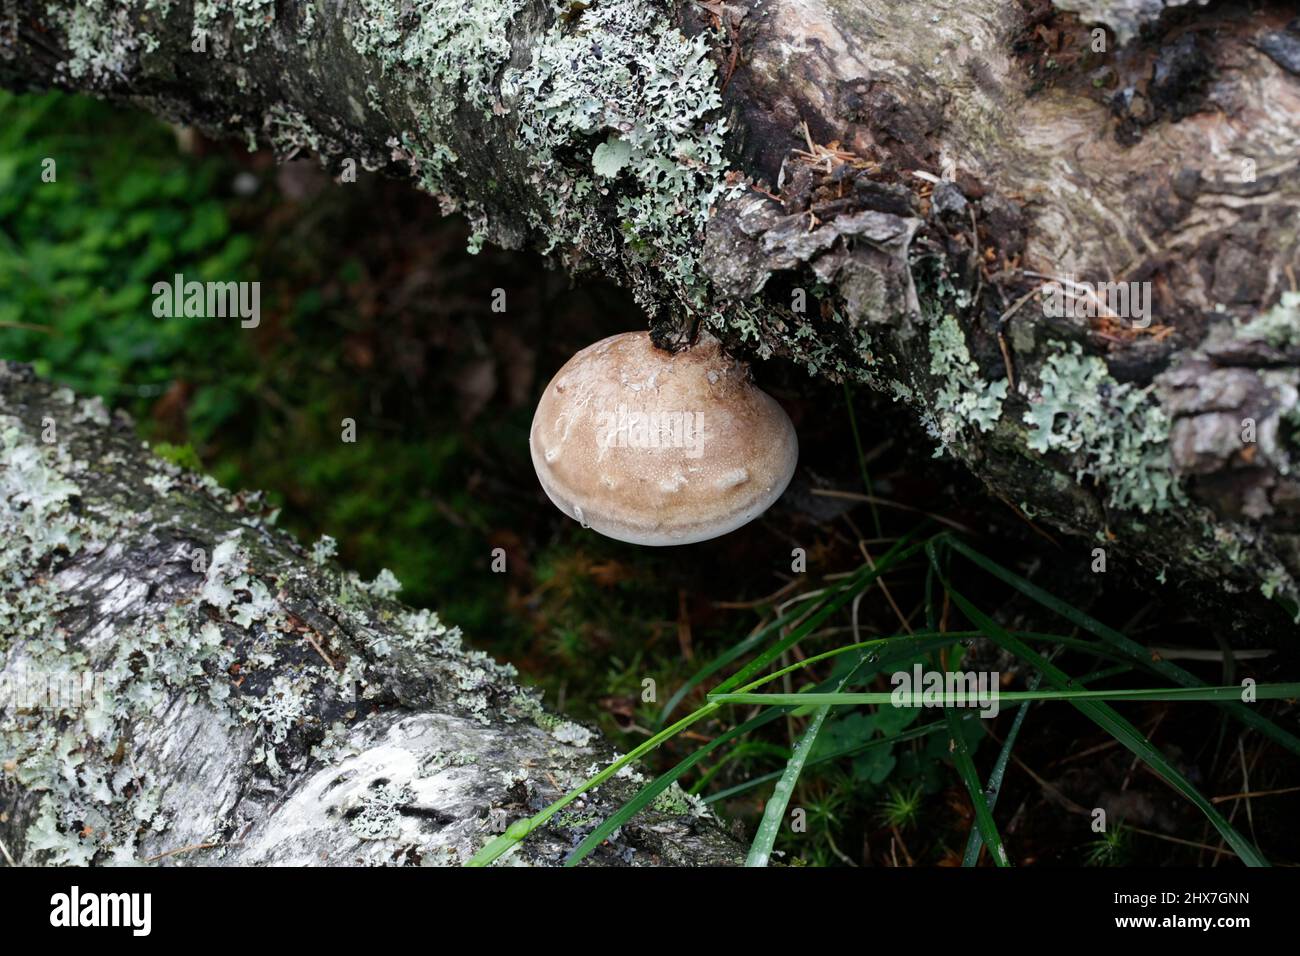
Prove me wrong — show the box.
[0,363,744,865]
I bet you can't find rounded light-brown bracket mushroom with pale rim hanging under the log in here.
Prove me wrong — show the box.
[528,332,798,545]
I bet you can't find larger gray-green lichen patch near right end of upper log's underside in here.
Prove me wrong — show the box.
[1023,343,1184,512]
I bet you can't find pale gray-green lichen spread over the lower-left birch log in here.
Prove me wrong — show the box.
[0,385,530,865]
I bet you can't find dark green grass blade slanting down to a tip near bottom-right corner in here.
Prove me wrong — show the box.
[944,581,1269,866]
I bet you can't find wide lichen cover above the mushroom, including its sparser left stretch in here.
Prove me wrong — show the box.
[350,0,729,291]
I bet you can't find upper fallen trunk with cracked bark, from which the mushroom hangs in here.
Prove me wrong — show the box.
[0,0,1300,629]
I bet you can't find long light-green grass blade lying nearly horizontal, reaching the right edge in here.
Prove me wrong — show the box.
[709,686,1300,708]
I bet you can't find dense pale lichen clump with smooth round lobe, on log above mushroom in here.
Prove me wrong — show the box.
[502,0,729,291]
